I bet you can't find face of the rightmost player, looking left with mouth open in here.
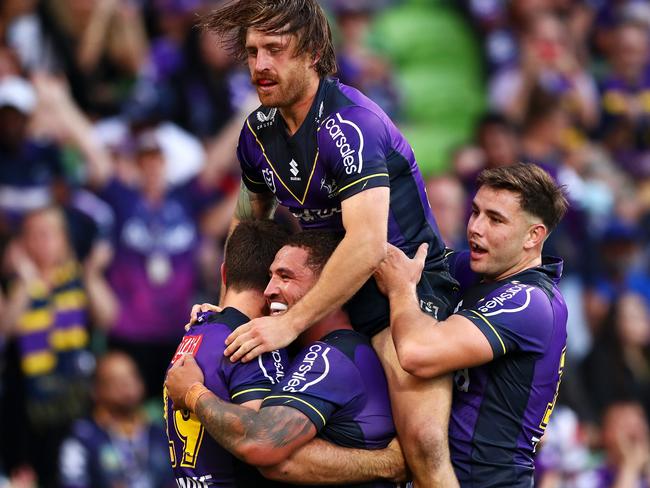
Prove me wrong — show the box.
[467,186,546,281]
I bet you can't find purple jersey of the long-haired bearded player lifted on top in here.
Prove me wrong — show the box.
[237,78,446,270]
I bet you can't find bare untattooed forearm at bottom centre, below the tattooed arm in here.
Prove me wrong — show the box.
[260,439,406,484]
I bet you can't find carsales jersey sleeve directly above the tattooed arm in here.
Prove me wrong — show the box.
[262,342,363,432]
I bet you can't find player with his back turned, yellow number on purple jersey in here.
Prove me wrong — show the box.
[164,221,289,487]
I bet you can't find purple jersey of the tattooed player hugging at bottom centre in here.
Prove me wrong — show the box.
[262,329,395,488]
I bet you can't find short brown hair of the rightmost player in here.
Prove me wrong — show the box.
[476,163,569,233]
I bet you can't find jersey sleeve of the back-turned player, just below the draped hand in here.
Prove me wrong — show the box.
[223,349,289,405]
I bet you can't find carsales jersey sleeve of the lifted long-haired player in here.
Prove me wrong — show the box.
[318,106,391,200]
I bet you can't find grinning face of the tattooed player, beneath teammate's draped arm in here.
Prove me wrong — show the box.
[264,246,318,315]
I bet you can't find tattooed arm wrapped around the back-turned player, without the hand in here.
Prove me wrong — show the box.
[195,393,316,466]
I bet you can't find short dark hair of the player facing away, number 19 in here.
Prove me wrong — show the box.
[224,220,289,291]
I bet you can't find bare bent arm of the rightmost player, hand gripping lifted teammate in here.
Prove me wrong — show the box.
[375,244,494,378]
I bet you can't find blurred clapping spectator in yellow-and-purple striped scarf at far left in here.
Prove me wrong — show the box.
[0,207,116,486]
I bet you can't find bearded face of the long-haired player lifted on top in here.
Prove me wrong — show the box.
[246,29,318,108]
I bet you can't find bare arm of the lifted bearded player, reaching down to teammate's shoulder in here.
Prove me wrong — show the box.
[225,187,390,361]
